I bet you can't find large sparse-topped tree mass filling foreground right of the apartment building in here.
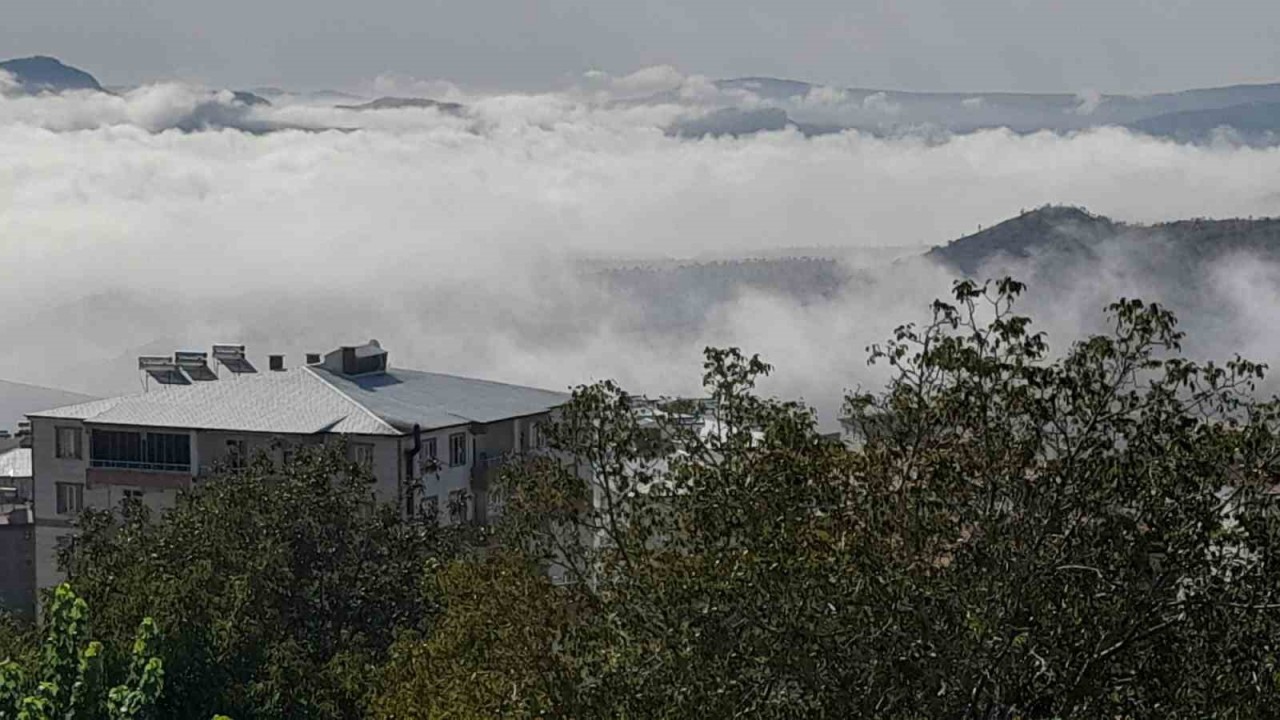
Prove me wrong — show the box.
[398,281,1280,717]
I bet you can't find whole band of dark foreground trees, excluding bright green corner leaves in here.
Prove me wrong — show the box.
[24,281,1280,719]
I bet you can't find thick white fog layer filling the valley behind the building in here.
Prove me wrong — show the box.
[0,68,1280,418]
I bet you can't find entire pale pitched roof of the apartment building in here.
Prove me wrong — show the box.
[31,366,568,436]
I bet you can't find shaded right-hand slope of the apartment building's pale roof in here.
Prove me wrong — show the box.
[307,366,568,432]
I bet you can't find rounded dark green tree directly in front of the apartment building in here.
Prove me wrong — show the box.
[63,443,458,719]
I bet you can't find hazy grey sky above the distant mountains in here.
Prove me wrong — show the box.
[0,0,1280,92]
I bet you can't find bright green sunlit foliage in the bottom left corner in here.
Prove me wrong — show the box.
[0,584,164,720]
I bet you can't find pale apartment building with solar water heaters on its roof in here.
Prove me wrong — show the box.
[28,341,568,588]
